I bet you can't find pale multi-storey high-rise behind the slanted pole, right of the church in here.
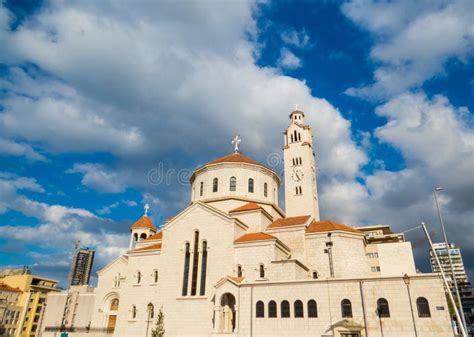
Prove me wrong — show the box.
[430,242,468,285]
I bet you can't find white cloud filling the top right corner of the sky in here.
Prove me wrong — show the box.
[342,0,474,99]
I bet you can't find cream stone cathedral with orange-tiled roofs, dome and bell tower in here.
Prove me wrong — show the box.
[88,110,452,337]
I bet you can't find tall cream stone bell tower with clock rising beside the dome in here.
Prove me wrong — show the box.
[283,109,319,221]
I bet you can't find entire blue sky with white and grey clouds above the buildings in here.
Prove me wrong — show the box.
[0,0,474,282]
